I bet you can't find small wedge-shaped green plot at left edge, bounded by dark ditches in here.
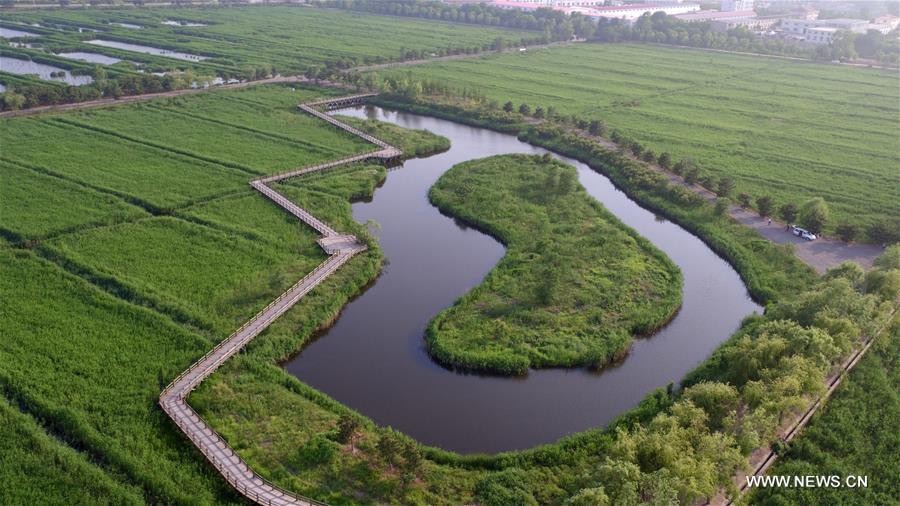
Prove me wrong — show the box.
[0,162,148,242]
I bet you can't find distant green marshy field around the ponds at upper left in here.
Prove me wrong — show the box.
[4,6,542,75]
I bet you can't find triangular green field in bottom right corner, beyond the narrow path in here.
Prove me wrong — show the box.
[751,319,900,505]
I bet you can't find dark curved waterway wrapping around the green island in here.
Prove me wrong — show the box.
[285,107,762,453]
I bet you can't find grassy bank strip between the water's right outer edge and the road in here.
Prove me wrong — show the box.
[376,97,815,303]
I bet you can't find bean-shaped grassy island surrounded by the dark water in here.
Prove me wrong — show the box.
[427,155,681,374]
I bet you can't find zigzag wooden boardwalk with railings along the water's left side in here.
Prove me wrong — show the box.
[159,94,402,506]
